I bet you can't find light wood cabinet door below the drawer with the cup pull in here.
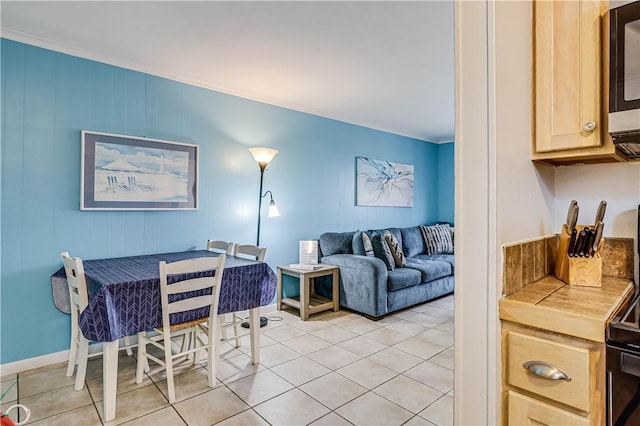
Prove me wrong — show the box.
[509,391,589,426]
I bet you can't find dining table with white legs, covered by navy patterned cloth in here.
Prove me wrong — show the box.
[51,250,277,422]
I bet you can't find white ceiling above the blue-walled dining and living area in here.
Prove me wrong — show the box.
[0,0,454,142]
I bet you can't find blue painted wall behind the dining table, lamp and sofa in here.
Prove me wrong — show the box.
[0,39,453,364]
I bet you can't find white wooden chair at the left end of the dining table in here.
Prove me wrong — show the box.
[61,251,135,391]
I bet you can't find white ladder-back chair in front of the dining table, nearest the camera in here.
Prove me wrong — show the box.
[136,254,226,404]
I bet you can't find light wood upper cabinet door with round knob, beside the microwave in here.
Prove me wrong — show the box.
[533,0,602,152]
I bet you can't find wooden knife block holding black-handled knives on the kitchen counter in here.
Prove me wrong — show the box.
[555,225,604,287]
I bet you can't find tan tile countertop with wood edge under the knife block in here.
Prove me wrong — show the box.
[499,275,634,342]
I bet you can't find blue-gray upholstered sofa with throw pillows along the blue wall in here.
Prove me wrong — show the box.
[320,226,455,319]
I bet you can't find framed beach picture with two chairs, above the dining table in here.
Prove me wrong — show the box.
[80,130,198,210]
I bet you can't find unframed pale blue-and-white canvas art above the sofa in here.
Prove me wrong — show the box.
[356,157,414,207]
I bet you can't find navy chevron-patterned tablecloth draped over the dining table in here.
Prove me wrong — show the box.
[51,250,276,342]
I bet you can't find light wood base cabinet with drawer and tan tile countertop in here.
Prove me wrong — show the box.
[499,276,634,426]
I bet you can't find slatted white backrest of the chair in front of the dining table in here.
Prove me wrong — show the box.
[160,254,227,331]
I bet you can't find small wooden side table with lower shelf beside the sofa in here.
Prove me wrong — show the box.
[277,265,340,321]
